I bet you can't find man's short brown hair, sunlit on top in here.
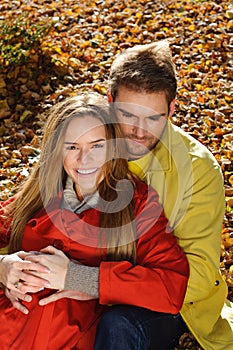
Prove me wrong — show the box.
[108,40,177,106]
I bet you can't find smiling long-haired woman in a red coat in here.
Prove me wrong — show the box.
[0,94,188,350]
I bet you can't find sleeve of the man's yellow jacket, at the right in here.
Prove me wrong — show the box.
[177,157,225,303]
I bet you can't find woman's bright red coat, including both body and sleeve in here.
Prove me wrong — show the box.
[0,182,189,350]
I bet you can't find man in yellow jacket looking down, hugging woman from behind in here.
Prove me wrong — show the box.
[97,41,233,350]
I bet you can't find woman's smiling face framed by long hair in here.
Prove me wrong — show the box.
[63,115,107,199]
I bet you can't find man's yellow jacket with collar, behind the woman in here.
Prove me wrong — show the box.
[129,122,233,350]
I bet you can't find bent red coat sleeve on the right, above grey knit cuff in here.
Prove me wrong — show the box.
[99,184,189,314]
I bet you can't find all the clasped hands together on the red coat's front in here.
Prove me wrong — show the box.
[1,246,93,314]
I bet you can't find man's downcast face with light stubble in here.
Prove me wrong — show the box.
[114,86,169,159]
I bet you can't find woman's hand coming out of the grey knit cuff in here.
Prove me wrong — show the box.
[25,246,69,290]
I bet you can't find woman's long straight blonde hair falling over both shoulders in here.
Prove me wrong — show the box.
[8,93,136,262]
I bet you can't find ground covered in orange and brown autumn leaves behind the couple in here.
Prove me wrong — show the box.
[0,0,233,350]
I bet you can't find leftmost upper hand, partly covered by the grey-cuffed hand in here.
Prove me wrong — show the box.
[0,251,49,294]
